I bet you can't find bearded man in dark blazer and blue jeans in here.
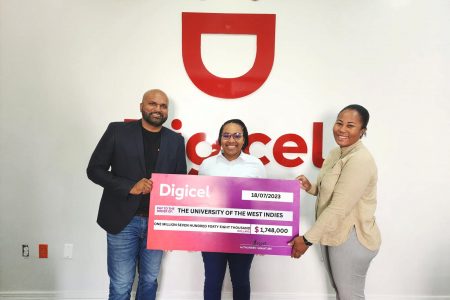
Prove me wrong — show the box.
[87,89,186,300]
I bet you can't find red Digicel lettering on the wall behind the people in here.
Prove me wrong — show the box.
[171,119,324,174]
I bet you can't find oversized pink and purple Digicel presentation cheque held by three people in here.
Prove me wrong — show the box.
[147,174,300,255]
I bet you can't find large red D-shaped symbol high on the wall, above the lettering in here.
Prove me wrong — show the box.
[182,12,275,99]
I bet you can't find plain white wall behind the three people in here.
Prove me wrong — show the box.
[0,0,450,299]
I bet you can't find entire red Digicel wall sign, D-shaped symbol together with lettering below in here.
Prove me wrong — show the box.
[179,12,323,174]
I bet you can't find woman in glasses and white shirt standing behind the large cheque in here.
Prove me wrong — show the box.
[198,119,266,300]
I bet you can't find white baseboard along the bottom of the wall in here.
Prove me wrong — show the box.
[0,291,450,300]
